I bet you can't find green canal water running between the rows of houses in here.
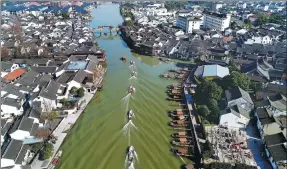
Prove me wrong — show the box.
[59,4,187,169]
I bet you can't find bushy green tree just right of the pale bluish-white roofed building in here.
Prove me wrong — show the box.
[221,71,250,90]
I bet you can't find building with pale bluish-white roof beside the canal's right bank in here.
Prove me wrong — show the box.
[194,65,229,80]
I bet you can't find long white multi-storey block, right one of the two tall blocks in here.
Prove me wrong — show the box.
[203,12,231,31]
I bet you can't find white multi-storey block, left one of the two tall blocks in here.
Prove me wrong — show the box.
[176,16,201,33]
